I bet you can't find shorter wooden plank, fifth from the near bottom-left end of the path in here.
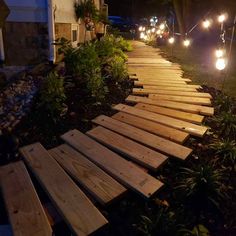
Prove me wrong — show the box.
[86,126,168,171]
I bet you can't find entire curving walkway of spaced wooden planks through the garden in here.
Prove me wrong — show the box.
[0,41,214,233]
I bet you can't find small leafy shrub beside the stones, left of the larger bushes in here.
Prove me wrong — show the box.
[39,72,66,121]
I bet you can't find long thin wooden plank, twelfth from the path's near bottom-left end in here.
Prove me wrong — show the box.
[133,88,212,99]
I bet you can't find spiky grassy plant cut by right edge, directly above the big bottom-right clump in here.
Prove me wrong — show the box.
[210,139,236,164]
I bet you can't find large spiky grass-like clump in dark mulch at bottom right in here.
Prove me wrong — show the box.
[175,163,228,210]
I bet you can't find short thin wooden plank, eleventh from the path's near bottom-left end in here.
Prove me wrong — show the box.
[148,94,211,105]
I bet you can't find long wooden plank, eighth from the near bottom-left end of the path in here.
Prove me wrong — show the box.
[113,104,207,137]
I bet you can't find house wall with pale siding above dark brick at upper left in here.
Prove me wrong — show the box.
[1,0,104,65]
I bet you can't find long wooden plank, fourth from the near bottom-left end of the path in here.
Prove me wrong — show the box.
[61,130,163,198]
